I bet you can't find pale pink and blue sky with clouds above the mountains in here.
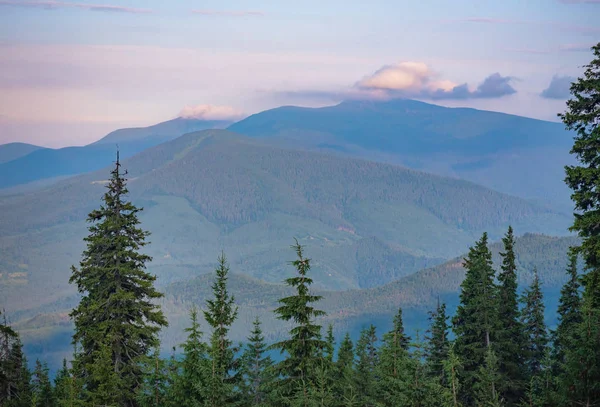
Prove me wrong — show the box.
[0,0,600,147]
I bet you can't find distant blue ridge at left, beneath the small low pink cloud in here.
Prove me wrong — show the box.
[0,118,231,188]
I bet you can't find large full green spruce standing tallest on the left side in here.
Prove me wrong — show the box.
[69,154,167,406]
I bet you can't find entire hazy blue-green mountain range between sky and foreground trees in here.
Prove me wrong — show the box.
[0,100,576,372]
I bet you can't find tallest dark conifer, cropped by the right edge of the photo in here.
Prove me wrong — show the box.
[559,43,600,406]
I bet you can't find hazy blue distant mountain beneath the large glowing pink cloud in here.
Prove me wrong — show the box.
[229,99,573,211]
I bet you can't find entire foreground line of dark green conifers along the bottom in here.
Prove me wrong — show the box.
[0,44,600,407]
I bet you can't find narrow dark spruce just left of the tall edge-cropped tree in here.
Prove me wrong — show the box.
[552,251,581,375]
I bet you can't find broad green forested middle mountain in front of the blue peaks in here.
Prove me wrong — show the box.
[0,130,569,314]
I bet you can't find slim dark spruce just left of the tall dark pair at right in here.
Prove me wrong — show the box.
[426,300,450,385]
